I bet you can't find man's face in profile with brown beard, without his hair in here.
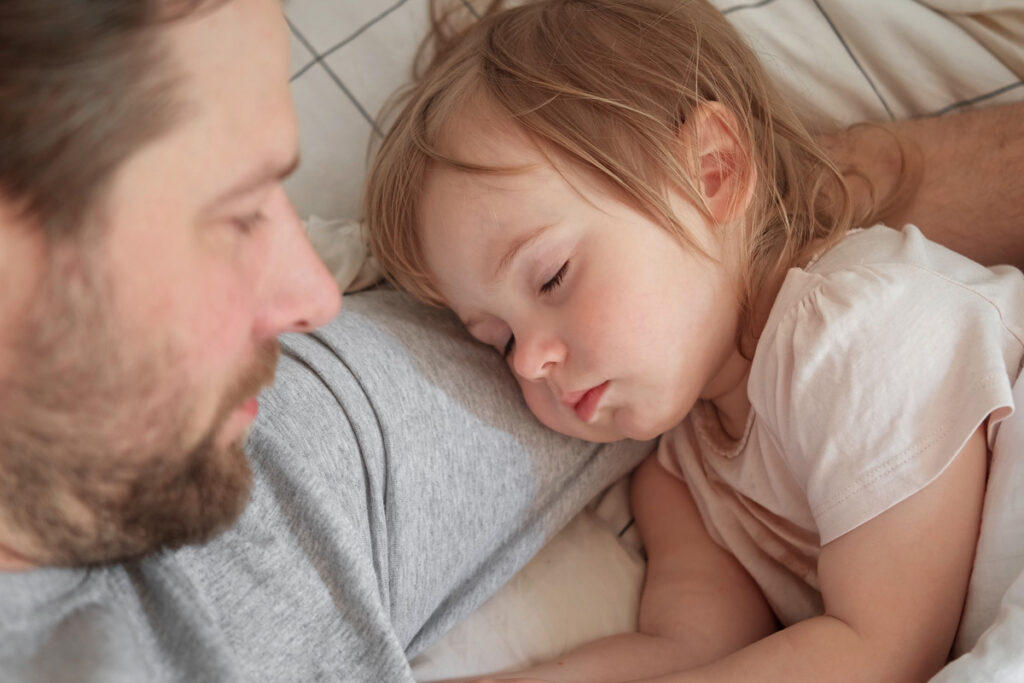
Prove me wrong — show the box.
[0,0,340,564]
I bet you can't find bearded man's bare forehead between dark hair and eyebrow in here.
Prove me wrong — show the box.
[97,0,298,225]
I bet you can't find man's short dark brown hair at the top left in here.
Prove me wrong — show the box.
[0,0,218,239]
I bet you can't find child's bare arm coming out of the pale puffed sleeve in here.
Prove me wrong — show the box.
[626,427,987,683]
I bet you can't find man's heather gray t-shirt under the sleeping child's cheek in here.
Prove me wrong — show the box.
[0,290,651,683]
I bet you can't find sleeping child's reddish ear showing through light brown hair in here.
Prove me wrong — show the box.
[680,102,757,223]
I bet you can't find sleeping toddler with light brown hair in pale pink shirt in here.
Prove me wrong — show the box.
[366,0,1024,682]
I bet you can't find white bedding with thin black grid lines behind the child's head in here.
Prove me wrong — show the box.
[286,0,1024,218]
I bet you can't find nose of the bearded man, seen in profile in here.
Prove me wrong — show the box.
[252,186,341,337]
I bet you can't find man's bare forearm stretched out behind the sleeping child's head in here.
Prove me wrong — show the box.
[820,102,1024,267]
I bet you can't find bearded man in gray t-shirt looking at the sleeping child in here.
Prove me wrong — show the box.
[0,0,1024,682]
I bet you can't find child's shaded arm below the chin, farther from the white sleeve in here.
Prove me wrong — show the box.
[464,455,778,683]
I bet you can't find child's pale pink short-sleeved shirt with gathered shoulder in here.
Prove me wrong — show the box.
[658,225,1024,625]
